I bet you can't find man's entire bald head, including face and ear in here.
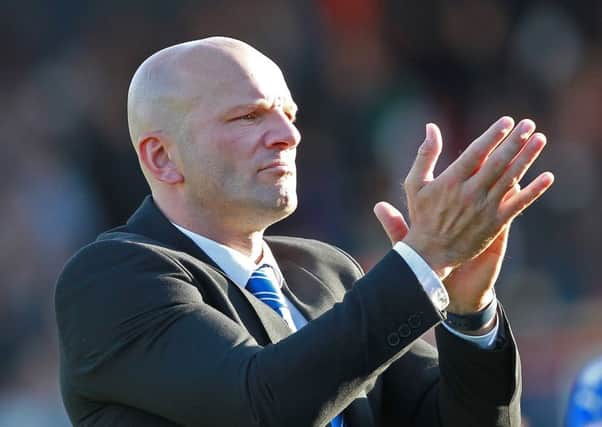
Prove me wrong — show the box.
[128,37,301,241]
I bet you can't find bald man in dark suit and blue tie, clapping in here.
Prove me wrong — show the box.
[56,37,553,427]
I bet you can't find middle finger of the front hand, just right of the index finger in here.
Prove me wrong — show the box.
[470,119,543,190]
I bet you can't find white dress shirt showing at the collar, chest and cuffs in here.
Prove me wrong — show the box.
[172,223,499,349]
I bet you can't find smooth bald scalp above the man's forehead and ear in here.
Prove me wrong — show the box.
[128,37,280,150]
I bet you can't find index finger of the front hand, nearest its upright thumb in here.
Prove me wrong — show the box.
[442,116,514,181]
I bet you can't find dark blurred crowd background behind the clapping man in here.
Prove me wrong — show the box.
[0,0,602,427]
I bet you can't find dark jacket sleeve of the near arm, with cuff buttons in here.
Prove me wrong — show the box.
[55,241,441,427]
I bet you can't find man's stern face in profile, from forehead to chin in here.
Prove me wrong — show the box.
[180,56,301,231]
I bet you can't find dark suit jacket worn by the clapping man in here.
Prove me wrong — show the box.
[55,197,520,427]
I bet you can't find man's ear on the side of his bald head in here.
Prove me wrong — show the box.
[138,135,184,185]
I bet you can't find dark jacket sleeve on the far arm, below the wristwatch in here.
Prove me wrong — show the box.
[383,306,521,427]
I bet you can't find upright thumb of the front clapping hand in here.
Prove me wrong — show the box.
[405,123,443,191]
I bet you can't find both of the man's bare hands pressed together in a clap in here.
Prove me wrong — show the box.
[374,117,554,314]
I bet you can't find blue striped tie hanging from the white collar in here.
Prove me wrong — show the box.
[246,264,345,427]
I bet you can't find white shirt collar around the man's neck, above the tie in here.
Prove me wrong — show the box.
[172,222,282,288]
